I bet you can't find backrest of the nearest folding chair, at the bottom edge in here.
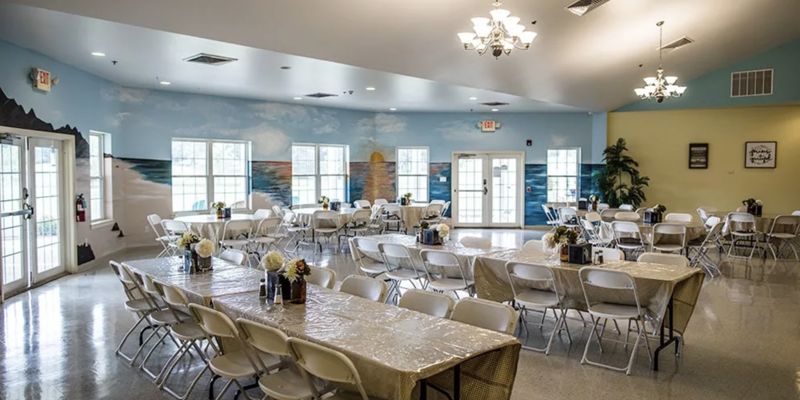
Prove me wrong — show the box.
[287,338,369,400]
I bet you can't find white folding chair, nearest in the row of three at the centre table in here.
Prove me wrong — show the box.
[420,249,475,298]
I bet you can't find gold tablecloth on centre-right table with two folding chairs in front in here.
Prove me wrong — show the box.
[475,250,704,333]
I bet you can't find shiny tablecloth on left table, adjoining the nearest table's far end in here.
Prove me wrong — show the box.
[122,257,264,307]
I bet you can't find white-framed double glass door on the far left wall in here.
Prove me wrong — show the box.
[0,136,65,293]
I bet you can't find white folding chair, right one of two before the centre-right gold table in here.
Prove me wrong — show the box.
[578,267,652,375]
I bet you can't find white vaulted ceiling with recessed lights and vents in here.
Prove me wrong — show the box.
[0,0,800,112]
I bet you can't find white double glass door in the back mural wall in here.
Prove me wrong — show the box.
[453,152,525,228]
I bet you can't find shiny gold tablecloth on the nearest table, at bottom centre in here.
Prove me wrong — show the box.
[214,285,520,400]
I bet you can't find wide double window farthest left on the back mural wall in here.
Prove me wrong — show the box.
[172,139,250,211]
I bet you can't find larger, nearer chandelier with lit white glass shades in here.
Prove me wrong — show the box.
[458,1,536,58]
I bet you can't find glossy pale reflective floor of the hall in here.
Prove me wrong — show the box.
[0,230,800,400]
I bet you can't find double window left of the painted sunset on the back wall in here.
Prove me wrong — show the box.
[292,144,348,204]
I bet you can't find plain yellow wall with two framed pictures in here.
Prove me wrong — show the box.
[608,106,800,216]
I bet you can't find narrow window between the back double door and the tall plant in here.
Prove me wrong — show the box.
[547,149,580,203]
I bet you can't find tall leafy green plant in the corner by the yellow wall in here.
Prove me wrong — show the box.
[592,138,650,208]
